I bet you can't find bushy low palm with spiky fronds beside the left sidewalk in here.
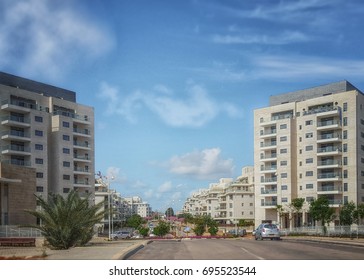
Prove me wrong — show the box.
[26,191,105,249]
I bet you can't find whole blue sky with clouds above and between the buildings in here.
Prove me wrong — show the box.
[0,0,364,211]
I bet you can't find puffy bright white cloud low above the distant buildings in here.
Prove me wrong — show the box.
[167,148,234,179]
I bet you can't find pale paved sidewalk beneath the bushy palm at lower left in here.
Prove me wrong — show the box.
[0,238,150,260]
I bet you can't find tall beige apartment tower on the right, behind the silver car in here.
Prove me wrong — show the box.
[254,81,364,228]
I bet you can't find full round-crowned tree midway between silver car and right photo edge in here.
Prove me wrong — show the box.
[309,196,335,234]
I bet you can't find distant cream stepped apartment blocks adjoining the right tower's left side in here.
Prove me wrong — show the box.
[183,166,255,224]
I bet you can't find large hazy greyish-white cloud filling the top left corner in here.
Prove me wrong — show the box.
[0,0,113,78]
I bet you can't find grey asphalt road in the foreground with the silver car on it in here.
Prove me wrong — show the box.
[129,239,364,260]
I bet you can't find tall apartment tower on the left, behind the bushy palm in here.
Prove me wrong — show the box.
[0,72,95,225]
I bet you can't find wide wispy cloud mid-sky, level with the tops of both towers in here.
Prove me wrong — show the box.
[99,83,241,127]
